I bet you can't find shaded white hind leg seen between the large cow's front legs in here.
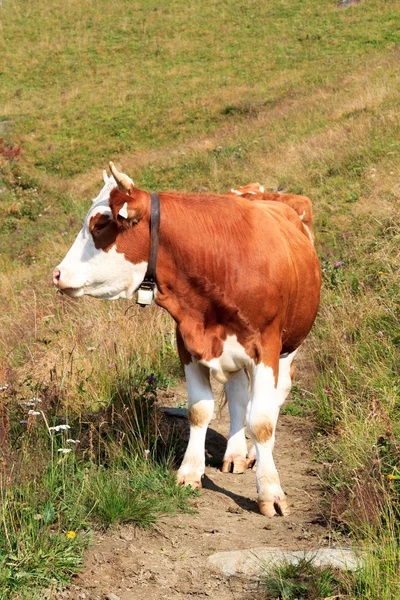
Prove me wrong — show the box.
[222,369,249,473]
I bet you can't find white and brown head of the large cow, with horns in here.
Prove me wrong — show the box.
[53,163,150,300]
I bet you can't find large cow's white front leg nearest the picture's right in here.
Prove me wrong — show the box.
[247,352,296,517]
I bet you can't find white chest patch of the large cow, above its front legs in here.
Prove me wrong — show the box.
[199,335,254,383]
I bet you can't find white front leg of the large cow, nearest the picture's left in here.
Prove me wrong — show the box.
[177,362,214,488]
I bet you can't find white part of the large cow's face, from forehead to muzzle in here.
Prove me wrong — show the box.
[54,177,147,300]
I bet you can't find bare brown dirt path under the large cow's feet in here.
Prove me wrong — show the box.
[64,388,329,600]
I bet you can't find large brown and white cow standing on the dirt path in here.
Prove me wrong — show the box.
[53,163,321,516]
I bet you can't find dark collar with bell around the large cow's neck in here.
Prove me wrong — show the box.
[137,194,160,306]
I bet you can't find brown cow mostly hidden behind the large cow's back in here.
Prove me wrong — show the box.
[226,183,314,243]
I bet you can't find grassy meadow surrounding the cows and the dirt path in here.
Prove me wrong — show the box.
[0,0,400,600]
